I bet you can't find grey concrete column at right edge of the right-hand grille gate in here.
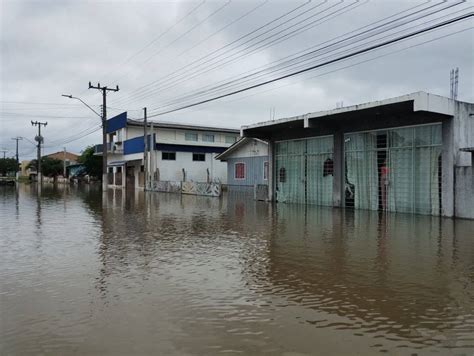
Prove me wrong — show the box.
[441,118,455,217]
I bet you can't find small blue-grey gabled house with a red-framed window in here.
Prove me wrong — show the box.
[216,138,269,189]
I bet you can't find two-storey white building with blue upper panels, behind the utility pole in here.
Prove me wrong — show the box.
[96,113,240,188]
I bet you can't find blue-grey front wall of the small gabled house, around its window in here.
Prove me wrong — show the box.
[227,156,270,186]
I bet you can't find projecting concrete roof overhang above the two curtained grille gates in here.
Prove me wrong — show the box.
[241,92,455,138]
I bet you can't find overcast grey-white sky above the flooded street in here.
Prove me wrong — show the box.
[0,0,474,159]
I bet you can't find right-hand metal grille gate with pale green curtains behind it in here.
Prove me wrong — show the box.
[344,124,442,215]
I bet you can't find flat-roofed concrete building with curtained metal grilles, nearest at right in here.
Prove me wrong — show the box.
[242,92,474,218]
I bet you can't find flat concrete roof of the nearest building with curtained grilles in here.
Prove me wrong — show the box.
[241,91,466,136]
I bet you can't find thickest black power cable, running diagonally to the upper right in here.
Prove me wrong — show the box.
[149,12,474,117]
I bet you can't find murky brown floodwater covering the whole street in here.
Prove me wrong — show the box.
[0,185,474,356]
